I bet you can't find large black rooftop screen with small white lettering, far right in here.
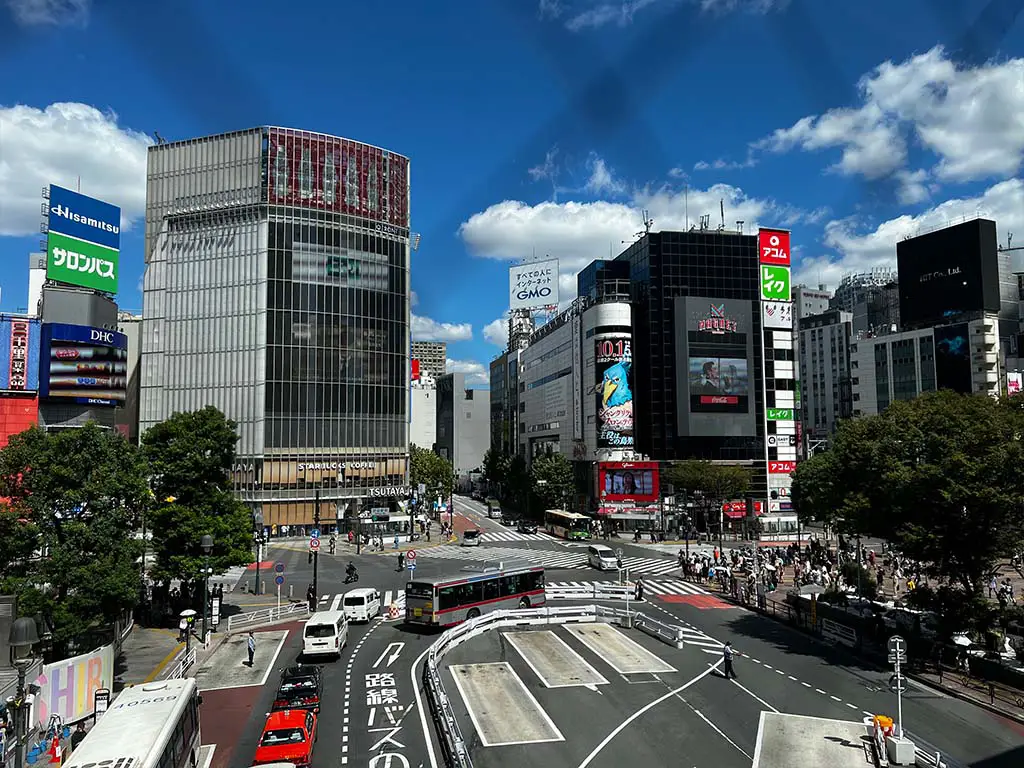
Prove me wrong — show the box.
[896,219,999,328]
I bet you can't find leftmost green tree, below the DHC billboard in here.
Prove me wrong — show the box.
[0,423,148,656]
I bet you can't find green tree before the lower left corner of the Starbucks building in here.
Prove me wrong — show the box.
[142,406,252,583]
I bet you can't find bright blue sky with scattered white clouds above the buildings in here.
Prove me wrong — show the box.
[0,0,1024,386]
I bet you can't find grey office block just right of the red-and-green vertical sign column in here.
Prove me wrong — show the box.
[799,309,853,440]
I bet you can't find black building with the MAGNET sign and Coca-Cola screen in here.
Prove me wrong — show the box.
[606,230,770,475]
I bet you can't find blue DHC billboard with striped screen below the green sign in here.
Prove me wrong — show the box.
[39,323,128,406]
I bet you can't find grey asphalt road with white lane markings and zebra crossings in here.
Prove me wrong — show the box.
[203,497,1024,768]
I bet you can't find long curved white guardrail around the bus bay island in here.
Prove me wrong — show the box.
[423,606,683,768]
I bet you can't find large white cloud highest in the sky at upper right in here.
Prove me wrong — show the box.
[754,46,1024,188]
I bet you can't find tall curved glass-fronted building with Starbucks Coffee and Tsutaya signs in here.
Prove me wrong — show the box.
[140,127,411,535]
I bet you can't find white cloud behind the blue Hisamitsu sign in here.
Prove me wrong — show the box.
[0,102,153,236]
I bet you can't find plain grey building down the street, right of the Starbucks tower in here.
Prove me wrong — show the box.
[435,374,490,487]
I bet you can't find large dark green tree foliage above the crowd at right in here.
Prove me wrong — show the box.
[793,391,1024,602]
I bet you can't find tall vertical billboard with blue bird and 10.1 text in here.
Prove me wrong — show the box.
[594,338,633,449]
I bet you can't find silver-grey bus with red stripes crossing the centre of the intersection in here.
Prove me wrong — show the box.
[406,564,545,627]
